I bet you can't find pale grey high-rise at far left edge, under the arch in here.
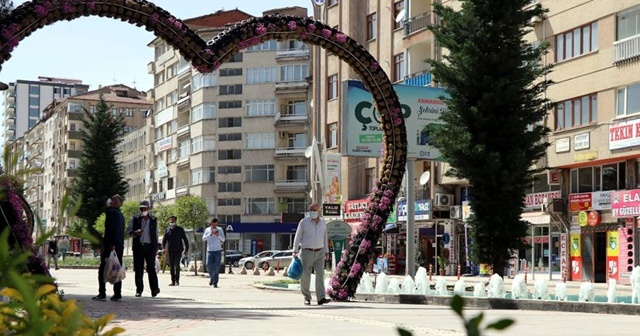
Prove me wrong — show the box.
[2,76,89,144]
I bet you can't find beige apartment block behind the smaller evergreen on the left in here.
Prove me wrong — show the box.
[26,84,153,233]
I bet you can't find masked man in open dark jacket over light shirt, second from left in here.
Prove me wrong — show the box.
[127,201,160,297]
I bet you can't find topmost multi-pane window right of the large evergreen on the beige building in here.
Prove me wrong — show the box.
[556,22,598,62]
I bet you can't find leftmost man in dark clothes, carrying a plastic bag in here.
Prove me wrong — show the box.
[93,195,124,301]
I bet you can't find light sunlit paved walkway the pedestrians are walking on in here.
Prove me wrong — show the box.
[53,269,638,336]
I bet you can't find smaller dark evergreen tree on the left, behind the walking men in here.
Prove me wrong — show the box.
[73,95,129,243]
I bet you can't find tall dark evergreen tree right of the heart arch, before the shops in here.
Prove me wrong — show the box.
[429,0,550,274]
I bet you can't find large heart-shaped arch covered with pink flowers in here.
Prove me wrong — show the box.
[0,0,407,300]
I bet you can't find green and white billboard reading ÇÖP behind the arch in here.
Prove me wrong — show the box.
[341,80,448,160]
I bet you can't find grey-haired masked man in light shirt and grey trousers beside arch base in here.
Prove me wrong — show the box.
[293,204,331,306]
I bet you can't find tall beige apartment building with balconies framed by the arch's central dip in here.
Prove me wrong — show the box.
[148,7,310,252]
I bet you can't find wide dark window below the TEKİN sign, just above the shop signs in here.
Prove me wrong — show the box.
[571,162,627,194]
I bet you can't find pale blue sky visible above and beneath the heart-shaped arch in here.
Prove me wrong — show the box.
[0,0,313,91]
